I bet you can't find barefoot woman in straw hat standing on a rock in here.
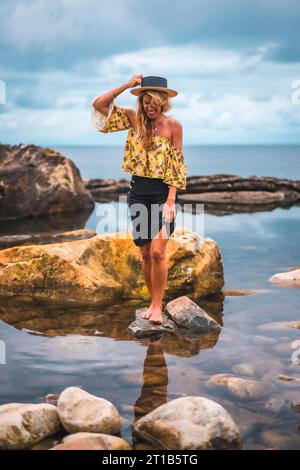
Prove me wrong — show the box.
[92,75,186,323]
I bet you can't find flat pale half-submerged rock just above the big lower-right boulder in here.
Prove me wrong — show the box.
[207,374,276,400]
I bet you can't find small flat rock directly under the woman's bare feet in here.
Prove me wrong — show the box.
[128,307,176,338]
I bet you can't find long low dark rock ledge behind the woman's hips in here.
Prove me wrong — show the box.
[84,174,300,215]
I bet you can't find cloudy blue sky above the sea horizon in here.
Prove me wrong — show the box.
[0,0,300,146]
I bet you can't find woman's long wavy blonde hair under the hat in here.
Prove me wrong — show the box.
[136,90,172,150]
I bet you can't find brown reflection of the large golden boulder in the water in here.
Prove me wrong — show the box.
[0,296,223,357]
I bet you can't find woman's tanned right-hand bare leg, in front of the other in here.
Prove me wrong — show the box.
[150,226,168,323]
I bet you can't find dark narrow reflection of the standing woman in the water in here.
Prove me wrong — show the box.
[134,337,168,421]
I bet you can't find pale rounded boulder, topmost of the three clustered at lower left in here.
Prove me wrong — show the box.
[57,387,121,434]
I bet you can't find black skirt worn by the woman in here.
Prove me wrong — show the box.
[128,175,179,246]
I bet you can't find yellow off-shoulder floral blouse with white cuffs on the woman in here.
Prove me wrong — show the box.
[92,100,187,190]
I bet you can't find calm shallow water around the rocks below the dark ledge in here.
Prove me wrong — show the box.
[0,204,300,449]
